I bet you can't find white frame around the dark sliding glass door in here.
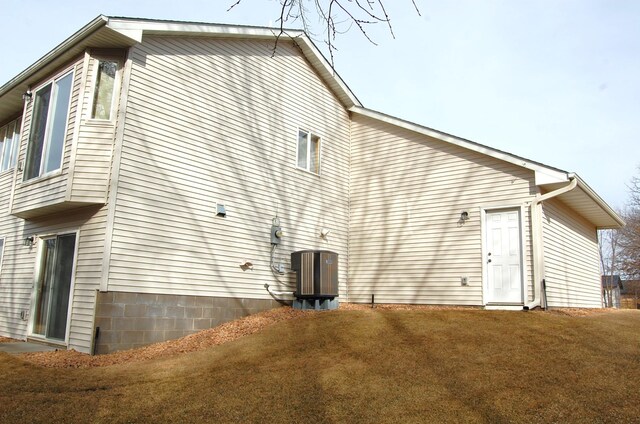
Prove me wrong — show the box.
[27,228,80,346]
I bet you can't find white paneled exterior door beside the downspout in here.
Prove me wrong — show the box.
[485,209,522,304]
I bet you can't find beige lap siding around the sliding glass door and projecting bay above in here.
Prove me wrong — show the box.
[0,54,113,352]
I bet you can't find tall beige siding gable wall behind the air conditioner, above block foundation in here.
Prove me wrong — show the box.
[108,37,349,299]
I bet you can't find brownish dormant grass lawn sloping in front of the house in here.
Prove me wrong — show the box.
[0,309,640,423]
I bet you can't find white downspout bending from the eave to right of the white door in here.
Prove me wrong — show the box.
[523,175,578,311]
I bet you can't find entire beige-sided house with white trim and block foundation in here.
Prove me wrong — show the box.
[0,16,623,353]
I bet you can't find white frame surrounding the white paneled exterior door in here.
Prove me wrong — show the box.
[480,204,529,309]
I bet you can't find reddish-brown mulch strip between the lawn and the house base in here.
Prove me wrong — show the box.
[15,303,610,368]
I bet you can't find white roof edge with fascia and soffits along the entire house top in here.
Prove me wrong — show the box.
[0,15,624,232]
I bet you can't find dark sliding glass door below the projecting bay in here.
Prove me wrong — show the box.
[32,234,76,340]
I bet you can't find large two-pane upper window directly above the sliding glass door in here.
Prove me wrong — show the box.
[24,72,73,180]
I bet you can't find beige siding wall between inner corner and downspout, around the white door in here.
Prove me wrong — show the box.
[349,114,535,305]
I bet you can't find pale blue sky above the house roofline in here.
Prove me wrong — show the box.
[0,0,640,208]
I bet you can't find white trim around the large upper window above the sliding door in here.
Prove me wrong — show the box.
[22,66,76,183]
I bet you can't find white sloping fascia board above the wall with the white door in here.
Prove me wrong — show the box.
[349,106,569,185]
